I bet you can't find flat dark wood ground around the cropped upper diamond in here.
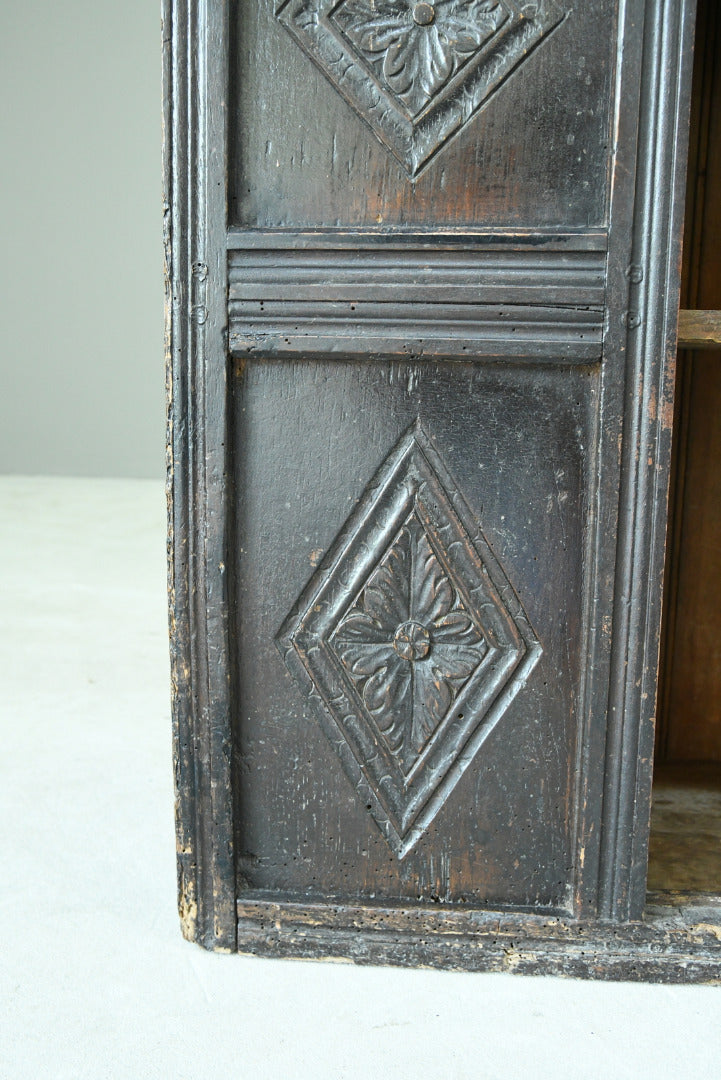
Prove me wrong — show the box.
[229,0,617,228]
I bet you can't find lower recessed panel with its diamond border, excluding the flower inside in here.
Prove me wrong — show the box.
[232,357,599,910]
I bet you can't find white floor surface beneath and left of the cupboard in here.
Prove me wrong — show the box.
[0,477,721,1080]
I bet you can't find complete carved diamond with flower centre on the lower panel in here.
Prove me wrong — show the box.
[277,424,541,858]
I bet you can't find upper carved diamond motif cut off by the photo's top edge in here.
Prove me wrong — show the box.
[276,0,566,178]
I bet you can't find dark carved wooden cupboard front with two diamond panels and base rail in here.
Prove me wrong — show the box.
[164,0,720,978]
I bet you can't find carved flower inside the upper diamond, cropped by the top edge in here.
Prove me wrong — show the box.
[334,0,508,117]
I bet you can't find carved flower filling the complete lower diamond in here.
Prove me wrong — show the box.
[335,516,488,772]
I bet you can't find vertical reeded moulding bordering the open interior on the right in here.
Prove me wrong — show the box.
[599,0,695,923]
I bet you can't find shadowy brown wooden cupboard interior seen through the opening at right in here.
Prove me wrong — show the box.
[657,0,721,761]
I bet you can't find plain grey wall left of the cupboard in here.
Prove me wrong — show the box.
[0,0,164,477]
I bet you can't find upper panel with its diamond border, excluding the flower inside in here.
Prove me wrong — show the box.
[226,0,617,225]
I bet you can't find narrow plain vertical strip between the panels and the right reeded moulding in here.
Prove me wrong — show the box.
[570,0,653,919]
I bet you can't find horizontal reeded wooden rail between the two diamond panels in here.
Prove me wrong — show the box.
[229,238,606,363]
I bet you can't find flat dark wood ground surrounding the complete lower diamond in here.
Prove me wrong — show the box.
[233,360,598,908]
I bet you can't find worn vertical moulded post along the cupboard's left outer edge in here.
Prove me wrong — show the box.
[162,0,235,949]
